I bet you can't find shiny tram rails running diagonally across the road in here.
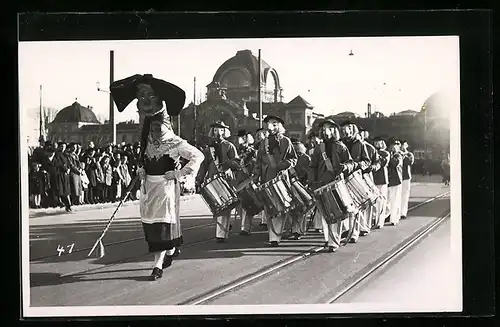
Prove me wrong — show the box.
[177,191,450,305]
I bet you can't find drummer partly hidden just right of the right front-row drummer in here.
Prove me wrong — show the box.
[341,121,371,243]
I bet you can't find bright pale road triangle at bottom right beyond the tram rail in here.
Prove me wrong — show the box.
[338,217,462,312]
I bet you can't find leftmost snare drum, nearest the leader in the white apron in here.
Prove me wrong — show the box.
[200,173,239,217]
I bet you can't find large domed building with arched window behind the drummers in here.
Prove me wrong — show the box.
[178,50,323,143]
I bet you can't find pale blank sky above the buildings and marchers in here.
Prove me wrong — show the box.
[19,36,459,127]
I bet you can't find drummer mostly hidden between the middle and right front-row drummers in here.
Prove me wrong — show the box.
[288,139,311,240]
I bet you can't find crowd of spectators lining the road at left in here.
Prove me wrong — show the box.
[28,141,140,212]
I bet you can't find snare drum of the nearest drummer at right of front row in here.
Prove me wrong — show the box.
[314,179,357,224]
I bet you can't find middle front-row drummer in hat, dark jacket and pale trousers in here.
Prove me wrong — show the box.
[253,116,297,247]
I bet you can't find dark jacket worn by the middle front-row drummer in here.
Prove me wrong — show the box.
[253,134,297,184]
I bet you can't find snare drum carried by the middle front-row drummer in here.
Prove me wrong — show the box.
[257,175,297,219]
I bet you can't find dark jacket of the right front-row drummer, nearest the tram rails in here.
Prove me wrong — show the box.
[309,140,355,189]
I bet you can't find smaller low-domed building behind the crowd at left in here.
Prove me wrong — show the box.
[48,101,139,146]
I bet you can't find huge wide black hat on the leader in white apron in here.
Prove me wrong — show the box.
[109,74,186,116]
